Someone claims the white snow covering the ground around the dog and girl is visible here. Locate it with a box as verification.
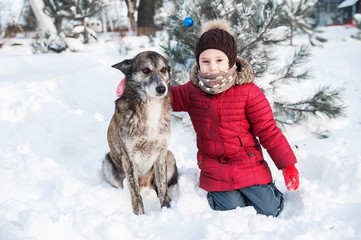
[0,27,361,240]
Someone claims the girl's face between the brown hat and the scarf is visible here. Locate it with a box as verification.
[199,49,229,74]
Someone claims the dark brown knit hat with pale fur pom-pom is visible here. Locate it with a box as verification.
[194,19,237,67]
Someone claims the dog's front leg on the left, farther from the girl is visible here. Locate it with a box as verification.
[123,157,144,215]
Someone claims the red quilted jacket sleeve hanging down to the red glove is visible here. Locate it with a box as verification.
[246,83,297,169]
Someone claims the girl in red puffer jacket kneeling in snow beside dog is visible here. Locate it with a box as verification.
[171,20,299,216]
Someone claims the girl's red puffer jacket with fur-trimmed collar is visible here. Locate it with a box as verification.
[171,58,297,191]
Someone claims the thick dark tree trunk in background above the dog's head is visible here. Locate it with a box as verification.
[137,0,156,37]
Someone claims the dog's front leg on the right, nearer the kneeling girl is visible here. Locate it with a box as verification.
[154,151,171,208]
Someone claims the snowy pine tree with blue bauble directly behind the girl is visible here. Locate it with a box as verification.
[163,0,344,135]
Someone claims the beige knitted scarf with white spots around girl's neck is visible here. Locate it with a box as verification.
[198,65,237,94]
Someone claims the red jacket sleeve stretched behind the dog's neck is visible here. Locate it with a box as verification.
[170,82,192,112]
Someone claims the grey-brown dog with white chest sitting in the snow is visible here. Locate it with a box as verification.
[102,51,178,215]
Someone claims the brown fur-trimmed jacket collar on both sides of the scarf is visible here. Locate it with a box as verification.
[189,57,254,87]
